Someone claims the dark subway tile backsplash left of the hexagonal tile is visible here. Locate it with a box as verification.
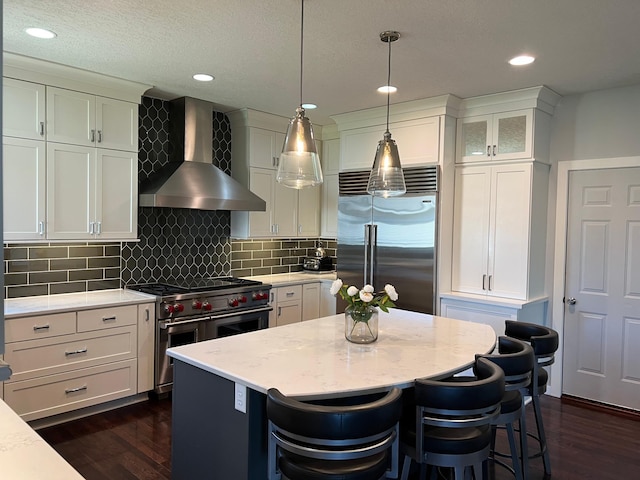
[4,243,121,298]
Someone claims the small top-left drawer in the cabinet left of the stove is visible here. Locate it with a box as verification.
[4,312,76,343]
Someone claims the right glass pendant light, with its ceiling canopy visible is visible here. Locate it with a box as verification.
[367,31,407,197]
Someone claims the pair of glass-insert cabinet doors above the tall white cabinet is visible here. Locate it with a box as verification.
[458,110,533,163]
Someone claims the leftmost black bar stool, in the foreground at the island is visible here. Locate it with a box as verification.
[267,388,402,480]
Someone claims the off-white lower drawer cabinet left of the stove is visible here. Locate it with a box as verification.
[4,304,155,421]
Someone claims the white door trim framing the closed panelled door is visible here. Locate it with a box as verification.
[547,157,640,397]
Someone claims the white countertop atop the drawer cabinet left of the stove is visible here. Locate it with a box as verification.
[4,288,156,318]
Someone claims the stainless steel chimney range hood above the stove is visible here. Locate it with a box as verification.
[139,97,267,212]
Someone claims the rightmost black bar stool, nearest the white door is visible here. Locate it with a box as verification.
[505,320,559,475]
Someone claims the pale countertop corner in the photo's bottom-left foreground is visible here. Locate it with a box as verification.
[0,400,84,480]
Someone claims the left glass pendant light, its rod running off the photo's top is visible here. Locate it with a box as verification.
[276,0,322,189]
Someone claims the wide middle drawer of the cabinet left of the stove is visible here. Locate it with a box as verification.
[5,325,137,382]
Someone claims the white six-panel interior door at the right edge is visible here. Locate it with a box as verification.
[563,168,640,409]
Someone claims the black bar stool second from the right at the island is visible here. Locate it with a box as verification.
[477,337,535,480]
